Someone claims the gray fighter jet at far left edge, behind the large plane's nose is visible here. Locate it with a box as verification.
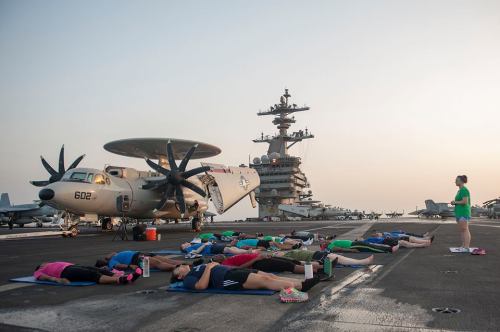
[0,193,57,229]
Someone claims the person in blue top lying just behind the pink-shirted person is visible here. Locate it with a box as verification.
[95,250,183,271]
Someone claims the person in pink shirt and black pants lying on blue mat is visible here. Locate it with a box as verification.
[33,262,142,285]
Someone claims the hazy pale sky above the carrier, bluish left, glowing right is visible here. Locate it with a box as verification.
[0,0,500,220]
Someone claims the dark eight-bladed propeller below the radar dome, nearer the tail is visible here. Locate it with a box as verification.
[142,141,210,215]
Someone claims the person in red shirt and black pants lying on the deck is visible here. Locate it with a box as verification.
[212,253,318,274]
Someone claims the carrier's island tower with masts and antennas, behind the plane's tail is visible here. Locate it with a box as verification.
[250,89,314,219]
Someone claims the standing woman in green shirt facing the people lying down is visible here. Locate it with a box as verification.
[451,175,471,252]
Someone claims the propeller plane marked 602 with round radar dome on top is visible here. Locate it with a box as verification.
[31,138,260,236]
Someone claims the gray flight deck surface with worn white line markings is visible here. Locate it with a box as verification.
[0,219,500,332]
